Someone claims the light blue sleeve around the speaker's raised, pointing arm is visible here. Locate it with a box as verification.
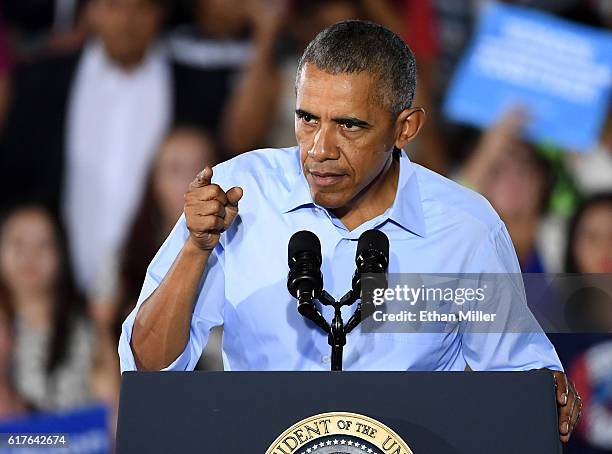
[119,214,225,372]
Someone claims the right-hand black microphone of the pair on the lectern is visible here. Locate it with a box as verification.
[347,229,389,332]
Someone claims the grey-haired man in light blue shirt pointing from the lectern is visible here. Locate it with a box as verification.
[119,21,580,439]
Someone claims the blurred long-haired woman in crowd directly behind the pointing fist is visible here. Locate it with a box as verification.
[91,127,218,394]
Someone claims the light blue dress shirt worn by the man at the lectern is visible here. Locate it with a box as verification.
[119,147,562,371]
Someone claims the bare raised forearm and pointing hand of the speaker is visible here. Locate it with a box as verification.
[131,167,242,370]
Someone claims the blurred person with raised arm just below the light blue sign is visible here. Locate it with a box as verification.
[458,110,552,273]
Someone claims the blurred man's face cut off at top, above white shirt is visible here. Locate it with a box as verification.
[91,0,163,67]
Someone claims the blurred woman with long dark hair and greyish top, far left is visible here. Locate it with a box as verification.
[0,205,93,410]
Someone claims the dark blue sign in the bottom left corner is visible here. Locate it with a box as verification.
[0,405,111,454]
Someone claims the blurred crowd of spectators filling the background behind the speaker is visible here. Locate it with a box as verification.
[0,0,612,452]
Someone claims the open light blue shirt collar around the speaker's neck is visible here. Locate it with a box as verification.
[281,150,426,237]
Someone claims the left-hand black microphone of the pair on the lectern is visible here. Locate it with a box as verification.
[287,230,323,304]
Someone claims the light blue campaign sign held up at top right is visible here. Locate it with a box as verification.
[444,3,612,151]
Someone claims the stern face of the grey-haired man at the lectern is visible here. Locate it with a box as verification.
[295,64,395,209]
